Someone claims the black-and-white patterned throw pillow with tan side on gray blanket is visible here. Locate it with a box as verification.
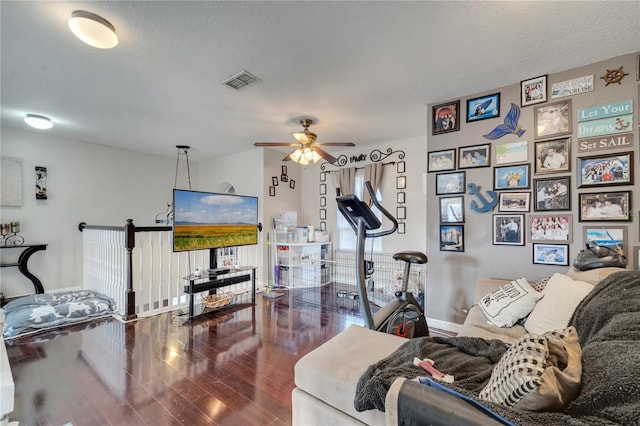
[478,327,582,411]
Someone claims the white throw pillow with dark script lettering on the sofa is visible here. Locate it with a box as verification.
[478,278,542,327]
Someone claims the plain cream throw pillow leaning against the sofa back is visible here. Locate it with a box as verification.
[524,273,593,334]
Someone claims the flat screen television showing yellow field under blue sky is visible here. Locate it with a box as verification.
[173,189,258,252]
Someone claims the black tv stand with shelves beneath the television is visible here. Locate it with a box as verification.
[184,266,257,320]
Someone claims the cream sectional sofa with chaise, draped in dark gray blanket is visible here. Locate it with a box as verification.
[292,267,640,425]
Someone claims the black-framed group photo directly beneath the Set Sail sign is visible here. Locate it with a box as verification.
[577,152,633,188]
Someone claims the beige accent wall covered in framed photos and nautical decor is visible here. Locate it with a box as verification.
[426,53,640,282]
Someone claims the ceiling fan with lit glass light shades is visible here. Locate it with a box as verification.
[253,118,356,166]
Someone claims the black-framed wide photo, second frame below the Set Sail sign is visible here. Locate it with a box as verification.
[578,191,631,222]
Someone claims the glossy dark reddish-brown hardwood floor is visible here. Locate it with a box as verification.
[7,286,448,426]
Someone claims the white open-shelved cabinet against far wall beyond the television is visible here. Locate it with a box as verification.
[276,242,331,288]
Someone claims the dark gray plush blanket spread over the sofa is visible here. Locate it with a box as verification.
[354,271,640,425]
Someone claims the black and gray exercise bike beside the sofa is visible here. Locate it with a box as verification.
[336,182,429,338]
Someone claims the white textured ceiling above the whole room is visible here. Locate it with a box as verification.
[0,1,640,159]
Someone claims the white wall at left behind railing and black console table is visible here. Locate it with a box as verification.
[0,128,190,297]
